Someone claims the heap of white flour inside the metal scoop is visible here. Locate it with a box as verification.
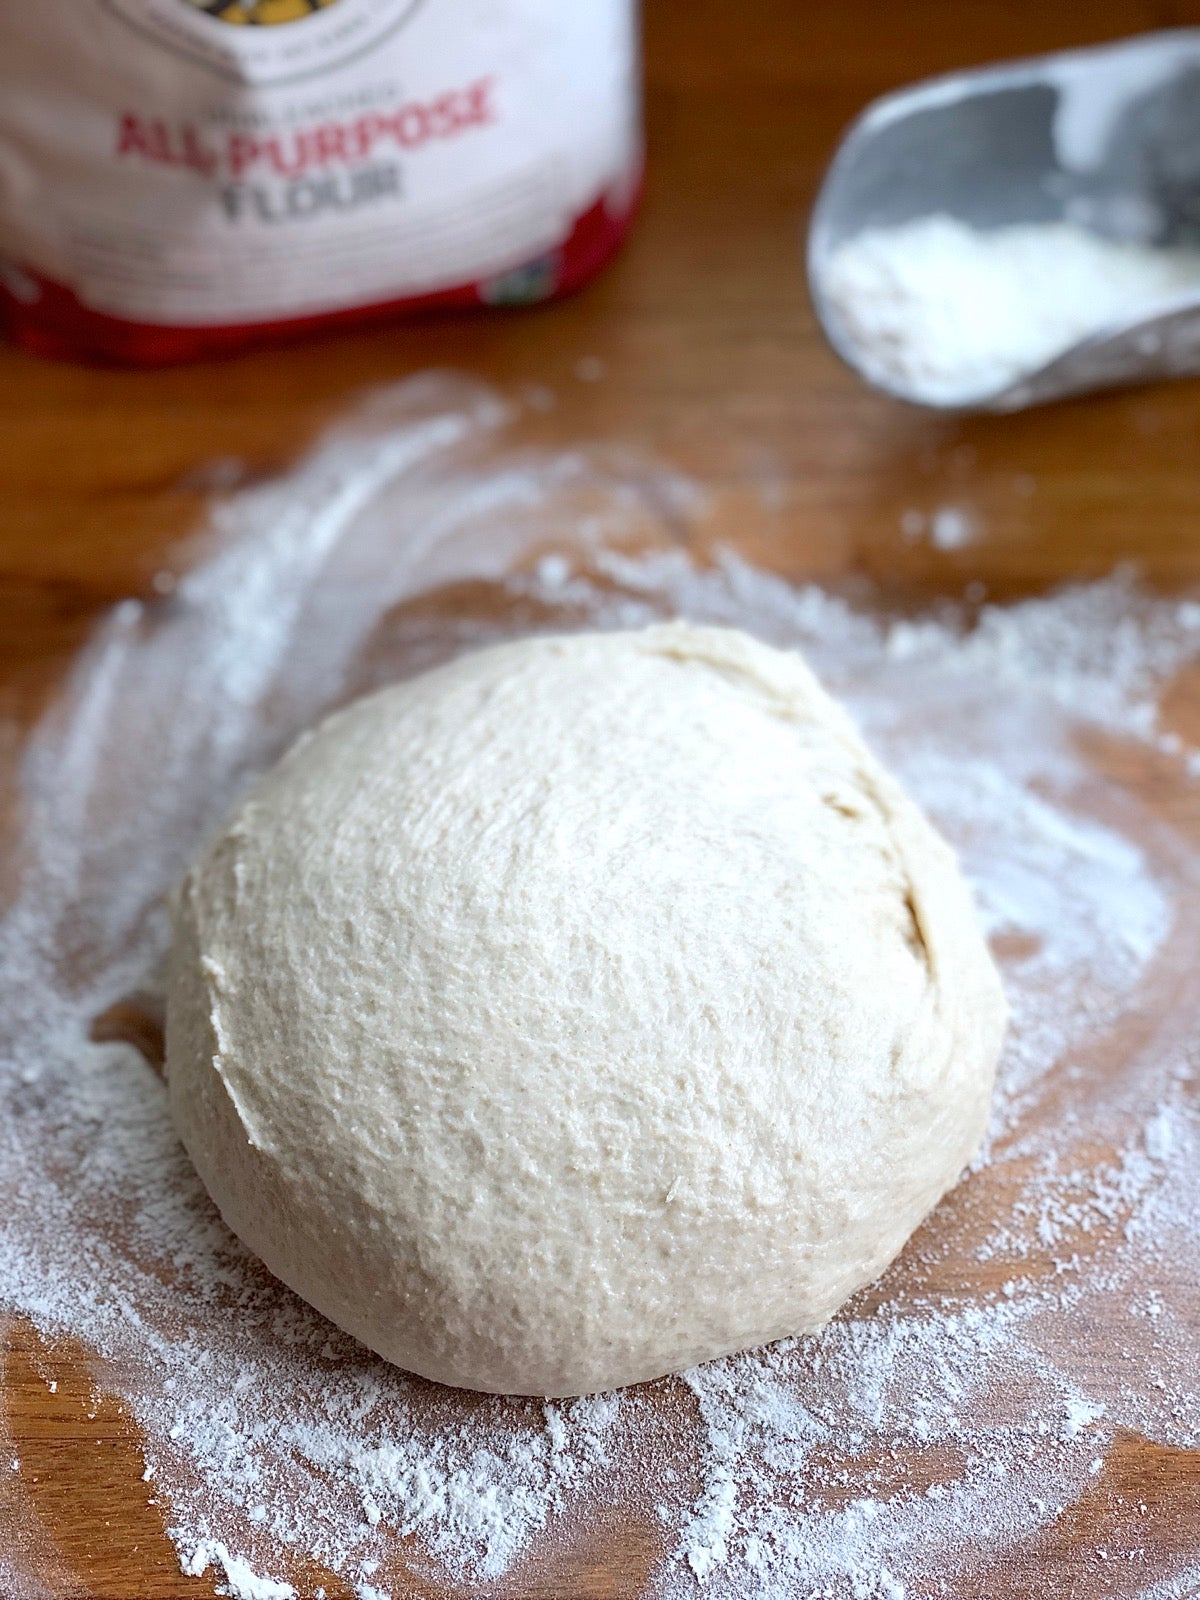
[821,214,1200,405]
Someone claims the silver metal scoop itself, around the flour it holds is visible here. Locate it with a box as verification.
[808,29,1200,411]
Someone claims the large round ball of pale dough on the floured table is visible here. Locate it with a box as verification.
[166,624,1005,1395]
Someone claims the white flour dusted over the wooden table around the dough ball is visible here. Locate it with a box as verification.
[0,379,1200,1600]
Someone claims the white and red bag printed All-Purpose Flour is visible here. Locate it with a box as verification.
[0,0,642,363]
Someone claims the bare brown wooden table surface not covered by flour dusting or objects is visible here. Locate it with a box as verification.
[0,0,1200,1600]
